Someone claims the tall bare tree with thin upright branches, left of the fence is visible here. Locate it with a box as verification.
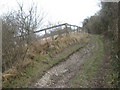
[16,3,43,62]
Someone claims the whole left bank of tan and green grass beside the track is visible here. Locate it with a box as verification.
[3,34,89,87]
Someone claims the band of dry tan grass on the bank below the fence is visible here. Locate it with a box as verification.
[2,33,88,84]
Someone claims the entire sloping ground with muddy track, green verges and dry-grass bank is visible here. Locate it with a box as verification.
[3,34,113,88]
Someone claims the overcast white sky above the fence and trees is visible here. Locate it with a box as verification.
[0,0,100,26]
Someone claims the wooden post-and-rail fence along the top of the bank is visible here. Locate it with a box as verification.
[17,23,84,40]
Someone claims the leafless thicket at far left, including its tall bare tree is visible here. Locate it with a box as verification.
[2,3,43,71]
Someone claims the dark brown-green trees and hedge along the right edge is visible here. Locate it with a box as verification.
[83,2,120,87]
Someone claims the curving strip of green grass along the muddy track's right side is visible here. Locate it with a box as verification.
[71,36,104,88]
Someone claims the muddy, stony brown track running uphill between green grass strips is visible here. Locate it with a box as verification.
[34,38,98,88]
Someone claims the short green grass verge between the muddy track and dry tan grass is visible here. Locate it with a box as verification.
[3,36,87,88]
